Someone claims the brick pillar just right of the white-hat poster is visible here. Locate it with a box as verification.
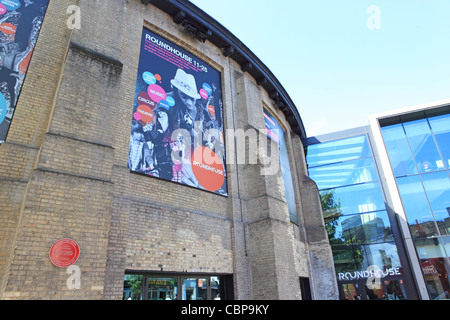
[235,71,300,299]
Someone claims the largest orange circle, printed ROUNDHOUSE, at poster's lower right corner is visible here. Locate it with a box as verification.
[191,147,225,192]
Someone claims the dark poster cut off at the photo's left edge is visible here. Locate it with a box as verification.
[0,0,49,144]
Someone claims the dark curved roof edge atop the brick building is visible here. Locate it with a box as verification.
[141,0,307,139]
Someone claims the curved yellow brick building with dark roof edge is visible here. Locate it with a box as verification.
[0,0,337,300]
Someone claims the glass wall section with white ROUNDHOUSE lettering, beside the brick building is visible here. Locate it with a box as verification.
[307,135,406,299]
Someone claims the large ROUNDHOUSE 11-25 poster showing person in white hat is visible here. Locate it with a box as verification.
[128,29,227,195]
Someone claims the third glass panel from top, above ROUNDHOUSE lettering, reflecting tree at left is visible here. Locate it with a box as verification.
[320,182,386,218]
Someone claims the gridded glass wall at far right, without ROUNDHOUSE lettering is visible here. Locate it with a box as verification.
[381,110,450,299]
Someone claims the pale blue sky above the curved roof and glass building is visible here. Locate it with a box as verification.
[187,0,450,136]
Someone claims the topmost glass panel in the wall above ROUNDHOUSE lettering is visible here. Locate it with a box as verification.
[306,135,371,167]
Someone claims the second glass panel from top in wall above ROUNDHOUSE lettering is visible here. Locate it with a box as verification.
[309,158,378,189]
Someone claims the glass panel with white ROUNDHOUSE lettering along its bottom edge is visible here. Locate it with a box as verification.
[332,242,401,274]
